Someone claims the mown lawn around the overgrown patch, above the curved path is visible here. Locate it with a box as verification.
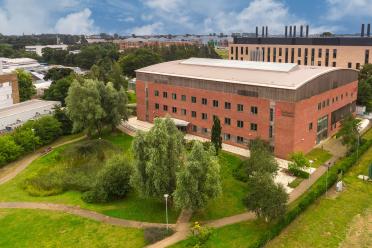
[0,133,179,223]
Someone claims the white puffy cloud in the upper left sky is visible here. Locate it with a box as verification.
[54,9,97,34]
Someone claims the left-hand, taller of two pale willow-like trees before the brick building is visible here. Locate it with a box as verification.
[132,118,185,199]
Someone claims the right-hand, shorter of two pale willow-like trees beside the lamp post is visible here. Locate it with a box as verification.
[173,142,222,210]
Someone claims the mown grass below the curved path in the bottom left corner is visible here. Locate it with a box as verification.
[0,209,145,248]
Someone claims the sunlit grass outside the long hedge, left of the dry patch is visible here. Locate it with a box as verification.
[267,145,372,248]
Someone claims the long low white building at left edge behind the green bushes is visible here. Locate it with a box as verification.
[0,99,60,132]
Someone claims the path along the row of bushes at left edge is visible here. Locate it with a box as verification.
[0,136,86,185]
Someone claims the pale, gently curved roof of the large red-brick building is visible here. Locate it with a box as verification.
[136,58,342,90]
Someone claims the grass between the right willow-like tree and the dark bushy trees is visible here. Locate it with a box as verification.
[193,152,247,221]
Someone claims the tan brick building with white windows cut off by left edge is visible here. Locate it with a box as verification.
[0,73,19,109]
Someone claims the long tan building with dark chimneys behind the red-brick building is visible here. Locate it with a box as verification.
[229,24,372,70]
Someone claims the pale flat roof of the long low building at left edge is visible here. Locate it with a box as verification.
[0,99,60,119]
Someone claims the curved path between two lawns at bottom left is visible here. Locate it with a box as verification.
[0,202,174,228]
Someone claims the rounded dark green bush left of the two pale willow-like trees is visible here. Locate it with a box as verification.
[83,156,133,202]
